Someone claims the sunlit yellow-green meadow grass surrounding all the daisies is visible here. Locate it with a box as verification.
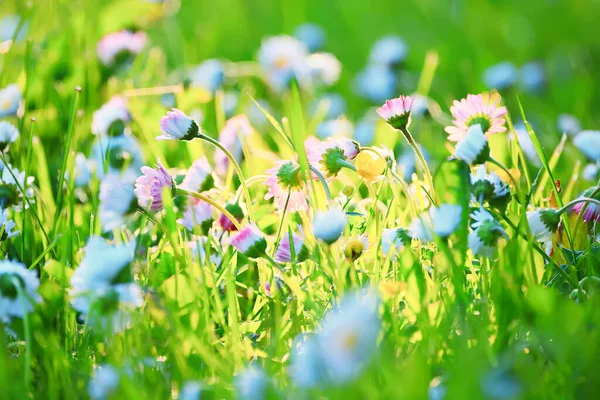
[0,0,600,399]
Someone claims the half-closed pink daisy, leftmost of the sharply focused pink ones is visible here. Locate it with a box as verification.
[134,161,173,211]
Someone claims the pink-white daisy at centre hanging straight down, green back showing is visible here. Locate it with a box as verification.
[265,161,308,213]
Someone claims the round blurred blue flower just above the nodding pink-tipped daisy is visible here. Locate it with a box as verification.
[354,65,398,103]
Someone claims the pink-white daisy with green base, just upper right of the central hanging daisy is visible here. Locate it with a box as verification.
[304,137,359,178]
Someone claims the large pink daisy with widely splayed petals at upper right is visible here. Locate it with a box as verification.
[445,93,508,142]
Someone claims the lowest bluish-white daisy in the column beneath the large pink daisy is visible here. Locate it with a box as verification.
[468,208,508,258]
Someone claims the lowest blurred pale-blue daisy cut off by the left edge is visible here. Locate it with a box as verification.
[0,260,42,324]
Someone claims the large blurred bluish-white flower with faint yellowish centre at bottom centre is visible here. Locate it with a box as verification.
[317,293,381,384]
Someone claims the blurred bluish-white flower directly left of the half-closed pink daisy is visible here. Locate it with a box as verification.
[98,173,136,232]
